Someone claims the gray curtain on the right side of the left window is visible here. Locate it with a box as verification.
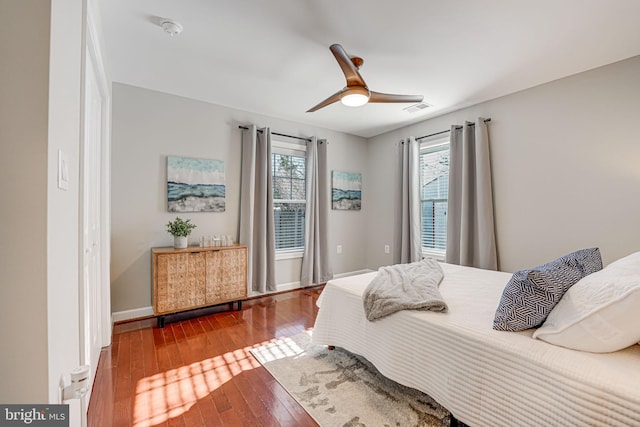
[300,137,333,286]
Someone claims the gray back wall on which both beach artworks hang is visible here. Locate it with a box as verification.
[111,84,370,312]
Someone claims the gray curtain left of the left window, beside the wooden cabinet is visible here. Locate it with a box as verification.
[240,125,276,292]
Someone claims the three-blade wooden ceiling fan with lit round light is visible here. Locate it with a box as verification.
[307,44,423,113]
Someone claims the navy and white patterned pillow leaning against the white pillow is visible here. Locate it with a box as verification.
[493,248,602,331]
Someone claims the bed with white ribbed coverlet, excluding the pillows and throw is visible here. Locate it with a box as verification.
[312,264,640,427]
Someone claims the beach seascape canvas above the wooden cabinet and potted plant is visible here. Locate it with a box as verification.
[167,156,226,212]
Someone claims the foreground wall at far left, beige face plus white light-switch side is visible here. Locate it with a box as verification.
[0,0,86,404]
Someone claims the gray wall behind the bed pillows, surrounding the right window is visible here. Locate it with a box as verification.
[366,57,640,271]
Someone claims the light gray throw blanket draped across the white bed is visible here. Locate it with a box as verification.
[363,258,447,320]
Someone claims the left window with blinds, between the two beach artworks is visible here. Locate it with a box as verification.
[271,141,307,252]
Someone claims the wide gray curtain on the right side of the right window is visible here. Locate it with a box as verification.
[445,117,498,270]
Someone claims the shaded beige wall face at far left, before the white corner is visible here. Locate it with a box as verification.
[0,1,51,403]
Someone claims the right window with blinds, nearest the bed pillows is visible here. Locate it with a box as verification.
[420,138,449,255]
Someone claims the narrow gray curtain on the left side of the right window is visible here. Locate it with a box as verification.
[393,137,422,264]
